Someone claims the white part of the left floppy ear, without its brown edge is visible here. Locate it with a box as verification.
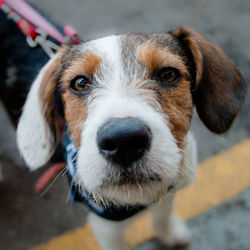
[17,58,55,170]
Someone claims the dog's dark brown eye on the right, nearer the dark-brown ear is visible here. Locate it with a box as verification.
[156,67,180,85]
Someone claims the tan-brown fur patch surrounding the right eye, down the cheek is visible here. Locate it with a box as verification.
[137,44,193,148]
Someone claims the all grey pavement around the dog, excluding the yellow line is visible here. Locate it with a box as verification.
[0,0,250,250]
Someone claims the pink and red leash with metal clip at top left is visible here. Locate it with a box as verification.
[0,0,81,58]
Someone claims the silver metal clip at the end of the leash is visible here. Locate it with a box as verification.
[26,28,59,58]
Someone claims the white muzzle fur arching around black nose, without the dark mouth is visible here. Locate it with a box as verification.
[78,96,181,202]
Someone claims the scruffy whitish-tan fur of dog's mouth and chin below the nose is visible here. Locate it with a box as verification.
[73,160,170,206]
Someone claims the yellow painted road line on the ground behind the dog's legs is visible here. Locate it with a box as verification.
[30,139,250,250]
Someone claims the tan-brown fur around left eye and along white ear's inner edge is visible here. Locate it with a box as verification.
[39,46,101,146]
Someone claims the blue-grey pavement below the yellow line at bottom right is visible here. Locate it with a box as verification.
[134,189,250,250]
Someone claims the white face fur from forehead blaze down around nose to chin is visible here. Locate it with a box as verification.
[74,36,195,204]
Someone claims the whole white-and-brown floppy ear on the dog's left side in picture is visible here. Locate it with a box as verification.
[17,49,63,170]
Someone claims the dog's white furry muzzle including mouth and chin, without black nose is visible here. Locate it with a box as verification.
[77,91,186,204]
